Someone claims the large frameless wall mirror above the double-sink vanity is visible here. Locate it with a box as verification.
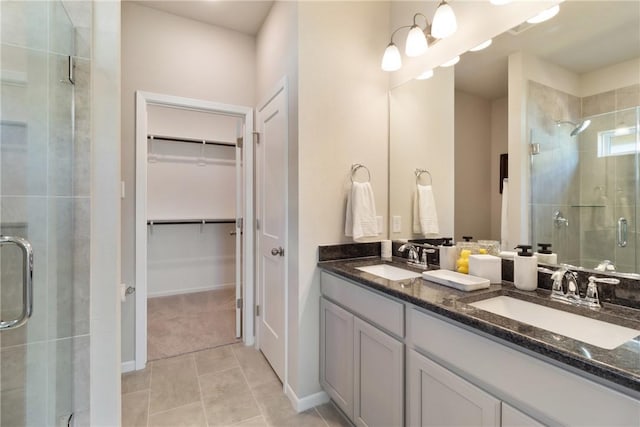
[389,1,640,273]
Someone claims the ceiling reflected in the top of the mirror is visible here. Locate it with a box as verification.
[455,1,640,99]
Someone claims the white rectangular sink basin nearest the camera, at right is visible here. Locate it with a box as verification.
[469,296,640,350]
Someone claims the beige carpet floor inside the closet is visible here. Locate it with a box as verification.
[147,288,238,360]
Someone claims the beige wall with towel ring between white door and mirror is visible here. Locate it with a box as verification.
[290,1,389,396]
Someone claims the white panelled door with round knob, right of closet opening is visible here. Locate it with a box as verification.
[256,85,288,382]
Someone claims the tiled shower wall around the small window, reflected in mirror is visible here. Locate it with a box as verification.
[578,84,640,272]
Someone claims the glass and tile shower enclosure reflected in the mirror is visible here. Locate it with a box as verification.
[527,82,640,273]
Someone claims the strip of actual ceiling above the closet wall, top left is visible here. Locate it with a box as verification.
[129,0,273,36]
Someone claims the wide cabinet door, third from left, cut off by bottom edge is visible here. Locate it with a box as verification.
[407,350,500,427]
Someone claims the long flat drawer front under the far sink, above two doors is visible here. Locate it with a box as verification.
[320,271,404,337]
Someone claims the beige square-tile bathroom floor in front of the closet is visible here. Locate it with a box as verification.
[122,343,350,427]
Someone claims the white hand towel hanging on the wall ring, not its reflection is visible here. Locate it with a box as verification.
[344,182,379,241]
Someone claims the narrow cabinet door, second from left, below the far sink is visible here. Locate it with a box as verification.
[353,317,404,427]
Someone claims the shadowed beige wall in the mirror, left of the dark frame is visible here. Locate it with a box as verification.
[454,90,492,241]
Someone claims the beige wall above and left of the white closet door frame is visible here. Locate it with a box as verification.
[121,2,256,362]
